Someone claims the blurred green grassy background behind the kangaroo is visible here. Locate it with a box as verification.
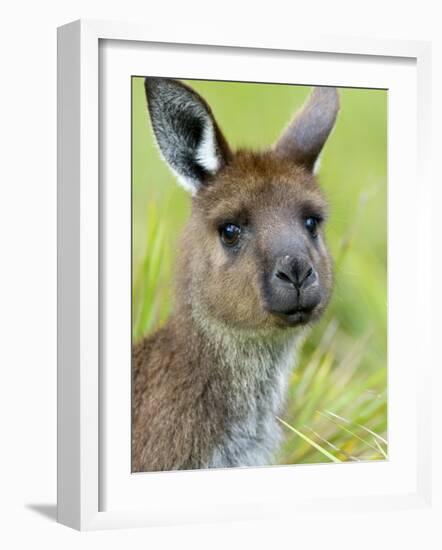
[132,77,387,464]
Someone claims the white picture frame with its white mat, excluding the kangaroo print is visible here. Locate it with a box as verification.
[58,21,432,530]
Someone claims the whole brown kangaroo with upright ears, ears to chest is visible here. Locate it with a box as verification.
[132,78,339,472]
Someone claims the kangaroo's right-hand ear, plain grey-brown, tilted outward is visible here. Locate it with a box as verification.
[274,88,339,171]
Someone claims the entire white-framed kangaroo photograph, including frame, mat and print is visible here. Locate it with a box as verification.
[58,21,432,530]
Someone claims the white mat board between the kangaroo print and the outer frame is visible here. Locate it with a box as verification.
[99,41,419,520]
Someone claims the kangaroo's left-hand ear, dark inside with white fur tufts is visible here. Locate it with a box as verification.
[145,77,231,195]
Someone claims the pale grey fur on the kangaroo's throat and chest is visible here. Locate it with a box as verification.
[193,308,296,468]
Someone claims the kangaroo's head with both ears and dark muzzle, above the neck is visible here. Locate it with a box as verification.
[145,78,339,330]
